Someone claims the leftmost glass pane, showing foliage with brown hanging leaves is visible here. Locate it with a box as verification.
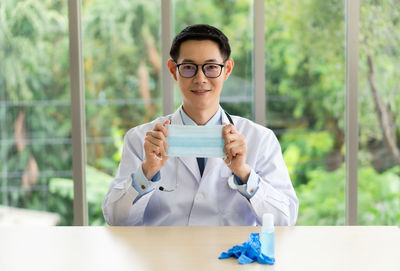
[0,0,73,225]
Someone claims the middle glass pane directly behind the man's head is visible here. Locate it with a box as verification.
[173,0,254,119]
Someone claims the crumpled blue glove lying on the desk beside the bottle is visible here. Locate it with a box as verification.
[218,233,275,265]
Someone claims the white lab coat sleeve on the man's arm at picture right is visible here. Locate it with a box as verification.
[250,131,299,226]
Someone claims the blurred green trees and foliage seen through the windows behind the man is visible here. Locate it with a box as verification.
[0,0,400,225]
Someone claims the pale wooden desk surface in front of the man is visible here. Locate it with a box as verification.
[0,226,400,271]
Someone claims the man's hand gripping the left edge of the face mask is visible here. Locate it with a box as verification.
[142,120,171,180]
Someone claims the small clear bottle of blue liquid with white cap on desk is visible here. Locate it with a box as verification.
[261,214,275,258]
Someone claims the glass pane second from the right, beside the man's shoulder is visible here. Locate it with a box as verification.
[265,0,345,225]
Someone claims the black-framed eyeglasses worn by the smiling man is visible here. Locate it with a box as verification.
[175,62,225,78]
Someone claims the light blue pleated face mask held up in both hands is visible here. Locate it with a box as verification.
[166,125,225,157]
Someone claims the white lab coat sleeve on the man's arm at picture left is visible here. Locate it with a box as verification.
[102,130,154,226]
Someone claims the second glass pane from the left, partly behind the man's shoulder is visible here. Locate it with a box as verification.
[82,0,164,225]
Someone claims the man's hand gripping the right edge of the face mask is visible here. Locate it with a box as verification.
[222,123,251,183]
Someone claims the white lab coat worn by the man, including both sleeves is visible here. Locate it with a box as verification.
[102,111,298,226]
